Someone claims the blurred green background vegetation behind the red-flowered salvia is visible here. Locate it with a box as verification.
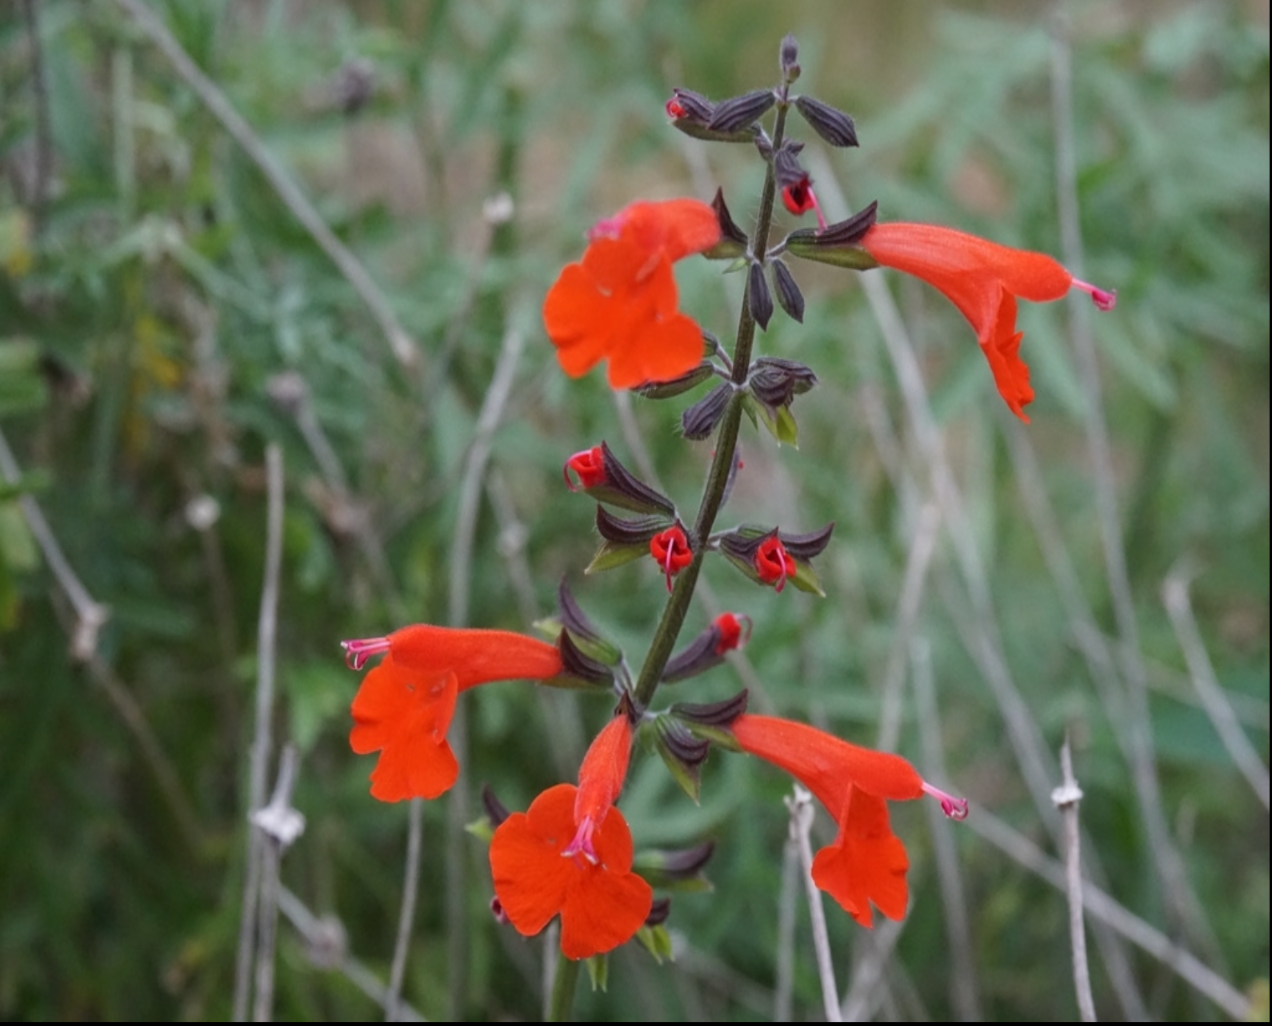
[0,0,1269,1021]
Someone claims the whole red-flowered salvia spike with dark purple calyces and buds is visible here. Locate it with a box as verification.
[343,37,1114,1017]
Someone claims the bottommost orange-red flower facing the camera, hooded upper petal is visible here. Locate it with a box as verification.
[490,712,654,959]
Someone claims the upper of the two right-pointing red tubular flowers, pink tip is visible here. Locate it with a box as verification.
[859,224,1117,423]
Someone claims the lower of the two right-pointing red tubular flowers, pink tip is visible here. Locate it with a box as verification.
[730,713,967,927]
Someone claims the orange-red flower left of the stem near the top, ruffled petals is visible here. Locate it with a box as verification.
[543,200,720,389]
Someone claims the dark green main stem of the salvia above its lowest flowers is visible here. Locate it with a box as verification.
[636,102,787,709]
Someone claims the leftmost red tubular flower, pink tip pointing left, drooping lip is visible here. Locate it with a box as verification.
[341,623,562,801]
